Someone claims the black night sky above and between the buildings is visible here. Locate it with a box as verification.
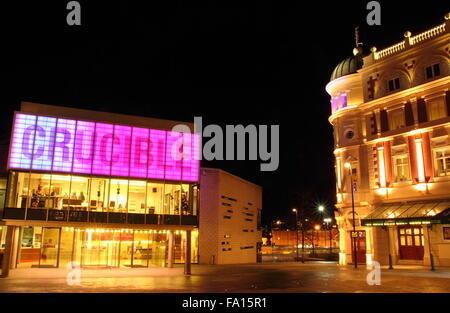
[0,0,450,223]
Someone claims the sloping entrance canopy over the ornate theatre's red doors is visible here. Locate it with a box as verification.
[361,199,450,226]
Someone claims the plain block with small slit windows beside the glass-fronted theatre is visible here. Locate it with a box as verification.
[199,168,262,264]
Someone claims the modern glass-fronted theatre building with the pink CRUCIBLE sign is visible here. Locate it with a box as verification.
[0,102,200,275]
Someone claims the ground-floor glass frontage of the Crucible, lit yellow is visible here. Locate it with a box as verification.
[18,226,198,268]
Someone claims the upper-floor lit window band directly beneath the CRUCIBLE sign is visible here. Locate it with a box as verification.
[6,171,198,224]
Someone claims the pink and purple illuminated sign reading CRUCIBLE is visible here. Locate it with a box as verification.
[8,113,200,182]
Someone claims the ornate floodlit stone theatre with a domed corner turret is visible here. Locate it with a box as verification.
[326,14,450,266]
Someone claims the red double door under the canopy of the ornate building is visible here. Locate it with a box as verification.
[398,226,424,260]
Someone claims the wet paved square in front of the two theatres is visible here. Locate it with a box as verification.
[0,262,450,293]
